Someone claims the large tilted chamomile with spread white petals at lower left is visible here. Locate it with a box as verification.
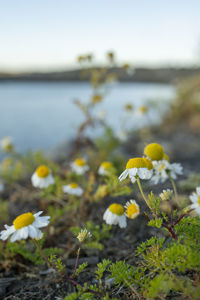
[0,211,50,242]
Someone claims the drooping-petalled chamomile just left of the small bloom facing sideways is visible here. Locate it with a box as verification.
[103,203,127,228]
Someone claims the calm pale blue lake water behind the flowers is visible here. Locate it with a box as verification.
[0,82,174,152]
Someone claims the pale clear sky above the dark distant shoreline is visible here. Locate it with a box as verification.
[0,0,200,71]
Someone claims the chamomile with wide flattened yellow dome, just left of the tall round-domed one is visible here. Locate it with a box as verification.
[119,157,153,183]
